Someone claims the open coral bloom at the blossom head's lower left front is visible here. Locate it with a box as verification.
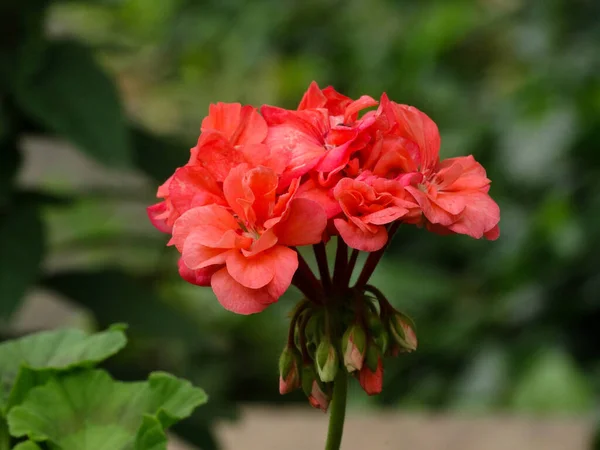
[172,164,327,314]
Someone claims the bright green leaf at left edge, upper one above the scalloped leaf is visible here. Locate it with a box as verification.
[0,326,127,412]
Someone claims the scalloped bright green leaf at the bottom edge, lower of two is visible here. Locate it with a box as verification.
[8,370,207,450]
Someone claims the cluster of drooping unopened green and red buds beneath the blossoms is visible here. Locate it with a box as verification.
[279,294,417,411]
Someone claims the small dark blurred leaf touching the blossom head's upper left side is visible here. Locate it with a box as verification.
[131,127,190,182]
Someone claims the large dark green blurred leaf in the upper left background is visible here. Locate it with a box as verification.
[14,41,132,167]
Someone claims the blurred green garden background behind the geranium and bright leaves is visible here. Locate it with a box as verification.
[0,0,600,450]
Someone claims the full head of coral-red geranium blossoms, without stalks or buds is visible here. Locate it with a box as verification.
[148,82,500,314]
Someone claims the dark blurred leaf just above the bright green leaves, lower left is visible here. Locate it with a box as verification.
[43,269,204,340]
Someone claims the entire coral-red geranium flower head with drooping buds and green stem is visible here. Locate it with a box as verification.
[148,82,500,449]
